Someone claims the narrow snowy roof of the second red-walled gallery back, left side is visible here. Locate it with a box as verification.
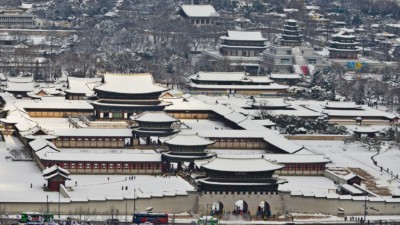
[53,128,132,137]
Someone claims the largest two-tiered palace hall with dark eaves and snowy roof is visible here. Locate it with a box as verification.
[92,73,170,120]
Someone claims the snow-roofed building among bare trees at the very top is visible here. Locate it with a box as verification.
[179,5,219,26]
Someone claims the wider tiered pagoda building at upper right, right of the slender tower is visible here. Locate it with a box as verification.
[328,31,361,59]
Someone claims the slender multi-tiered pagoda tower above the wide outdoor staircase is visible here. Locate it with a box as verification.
[281,19,303,46]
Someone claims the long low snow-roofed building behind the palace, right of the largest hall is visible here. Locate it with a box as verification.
[188,72,289,95]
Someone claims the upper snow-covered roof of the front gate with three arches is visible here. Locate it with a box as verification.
[195,156,284,172]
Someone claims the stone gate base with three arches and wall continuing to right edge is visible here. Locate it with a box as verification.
[198,192,400,216]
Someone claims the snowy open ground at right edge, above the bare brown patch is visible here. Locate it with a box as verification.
[293,140,400,194]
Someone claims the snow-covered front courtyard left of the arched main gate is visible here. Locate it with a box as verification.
[0,136,194,202]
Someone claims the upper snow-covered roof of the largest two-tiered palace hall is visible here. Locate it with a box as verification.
[94,73,167,94]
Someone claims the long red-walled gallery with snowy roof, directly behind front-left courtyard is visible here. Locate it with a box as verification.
[29,138,162,174]
